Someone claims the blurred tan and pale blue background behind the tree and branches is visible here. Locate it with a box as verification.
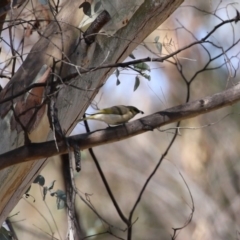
[1,0,240,240]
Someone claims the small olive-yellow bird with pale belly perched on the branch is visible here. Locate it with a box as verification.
[79,105,144,125]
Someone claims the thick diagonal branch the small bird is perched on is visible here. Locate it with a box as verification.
[0,84,240,169]
